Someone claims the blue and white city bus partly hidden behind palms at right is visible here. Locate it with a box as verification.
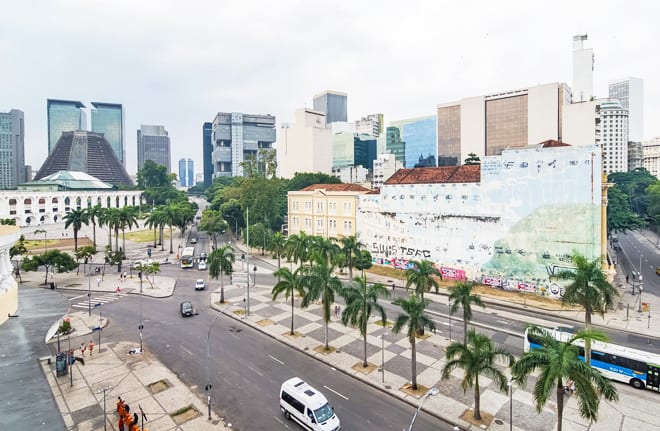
[523,328,660,392]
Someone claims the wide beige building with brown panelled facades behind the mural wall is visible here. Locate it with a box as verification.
[436,83,571,167]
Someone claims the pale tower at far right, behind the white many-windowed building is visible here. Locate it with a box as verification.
[609,77,644,142]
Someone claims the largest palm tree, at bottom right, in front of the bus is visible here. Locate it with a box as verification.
[511,326,619,431]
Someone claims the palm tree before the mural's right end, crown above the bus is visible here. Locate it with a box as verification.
[557,253,619,364]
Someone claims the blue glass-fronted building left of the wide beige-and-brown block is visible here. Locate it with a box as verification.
[390,116,438,168]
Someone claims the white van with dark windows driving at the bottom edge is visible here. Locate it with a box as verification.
[280,377,341,431]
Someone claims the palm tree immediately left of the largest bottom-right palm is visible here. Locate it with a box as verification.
[442,329,514,421]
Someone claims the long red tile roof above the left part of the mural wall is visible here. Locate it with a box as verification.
[385,165,481,184]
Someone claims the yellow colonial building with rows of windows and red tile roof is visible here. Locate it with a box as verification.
[287,184,371,238]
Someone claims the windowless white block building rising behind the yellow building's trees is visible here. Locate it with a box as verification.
[277,108,332,178]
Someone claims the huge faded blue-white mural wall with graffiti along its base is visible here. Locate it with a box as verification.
[358,146,601,296]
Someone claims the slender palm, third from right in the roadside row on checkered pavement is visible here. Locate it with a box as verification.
[392,293,435,391]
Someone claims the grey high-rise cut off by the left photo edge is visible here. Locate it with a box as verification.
[0,109,26,189]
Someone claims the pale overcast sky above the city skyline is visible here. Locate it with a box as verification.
[0,0,660,173]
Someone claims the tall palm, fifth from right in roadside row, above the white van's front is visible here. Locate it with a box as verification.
[301,254,342,350]
